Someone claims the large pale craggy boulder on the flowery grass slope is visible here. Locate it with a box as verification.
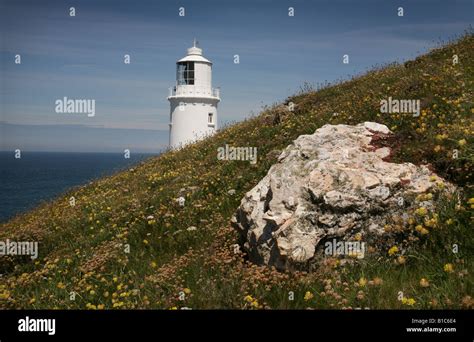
[232,122,452,270]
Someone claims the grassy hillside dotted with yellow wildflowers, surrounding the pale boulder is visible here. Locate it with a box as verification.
[0,33,474,309]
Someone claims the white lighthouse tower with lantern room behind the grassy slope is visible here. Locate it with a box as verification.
[168,40,220,149]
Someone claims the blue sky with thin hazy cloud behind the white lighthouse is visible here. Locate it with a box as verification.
[0,0,474,152]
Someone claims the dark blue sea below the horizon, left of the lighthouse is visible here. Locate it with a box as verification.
[0,151,153,222]
